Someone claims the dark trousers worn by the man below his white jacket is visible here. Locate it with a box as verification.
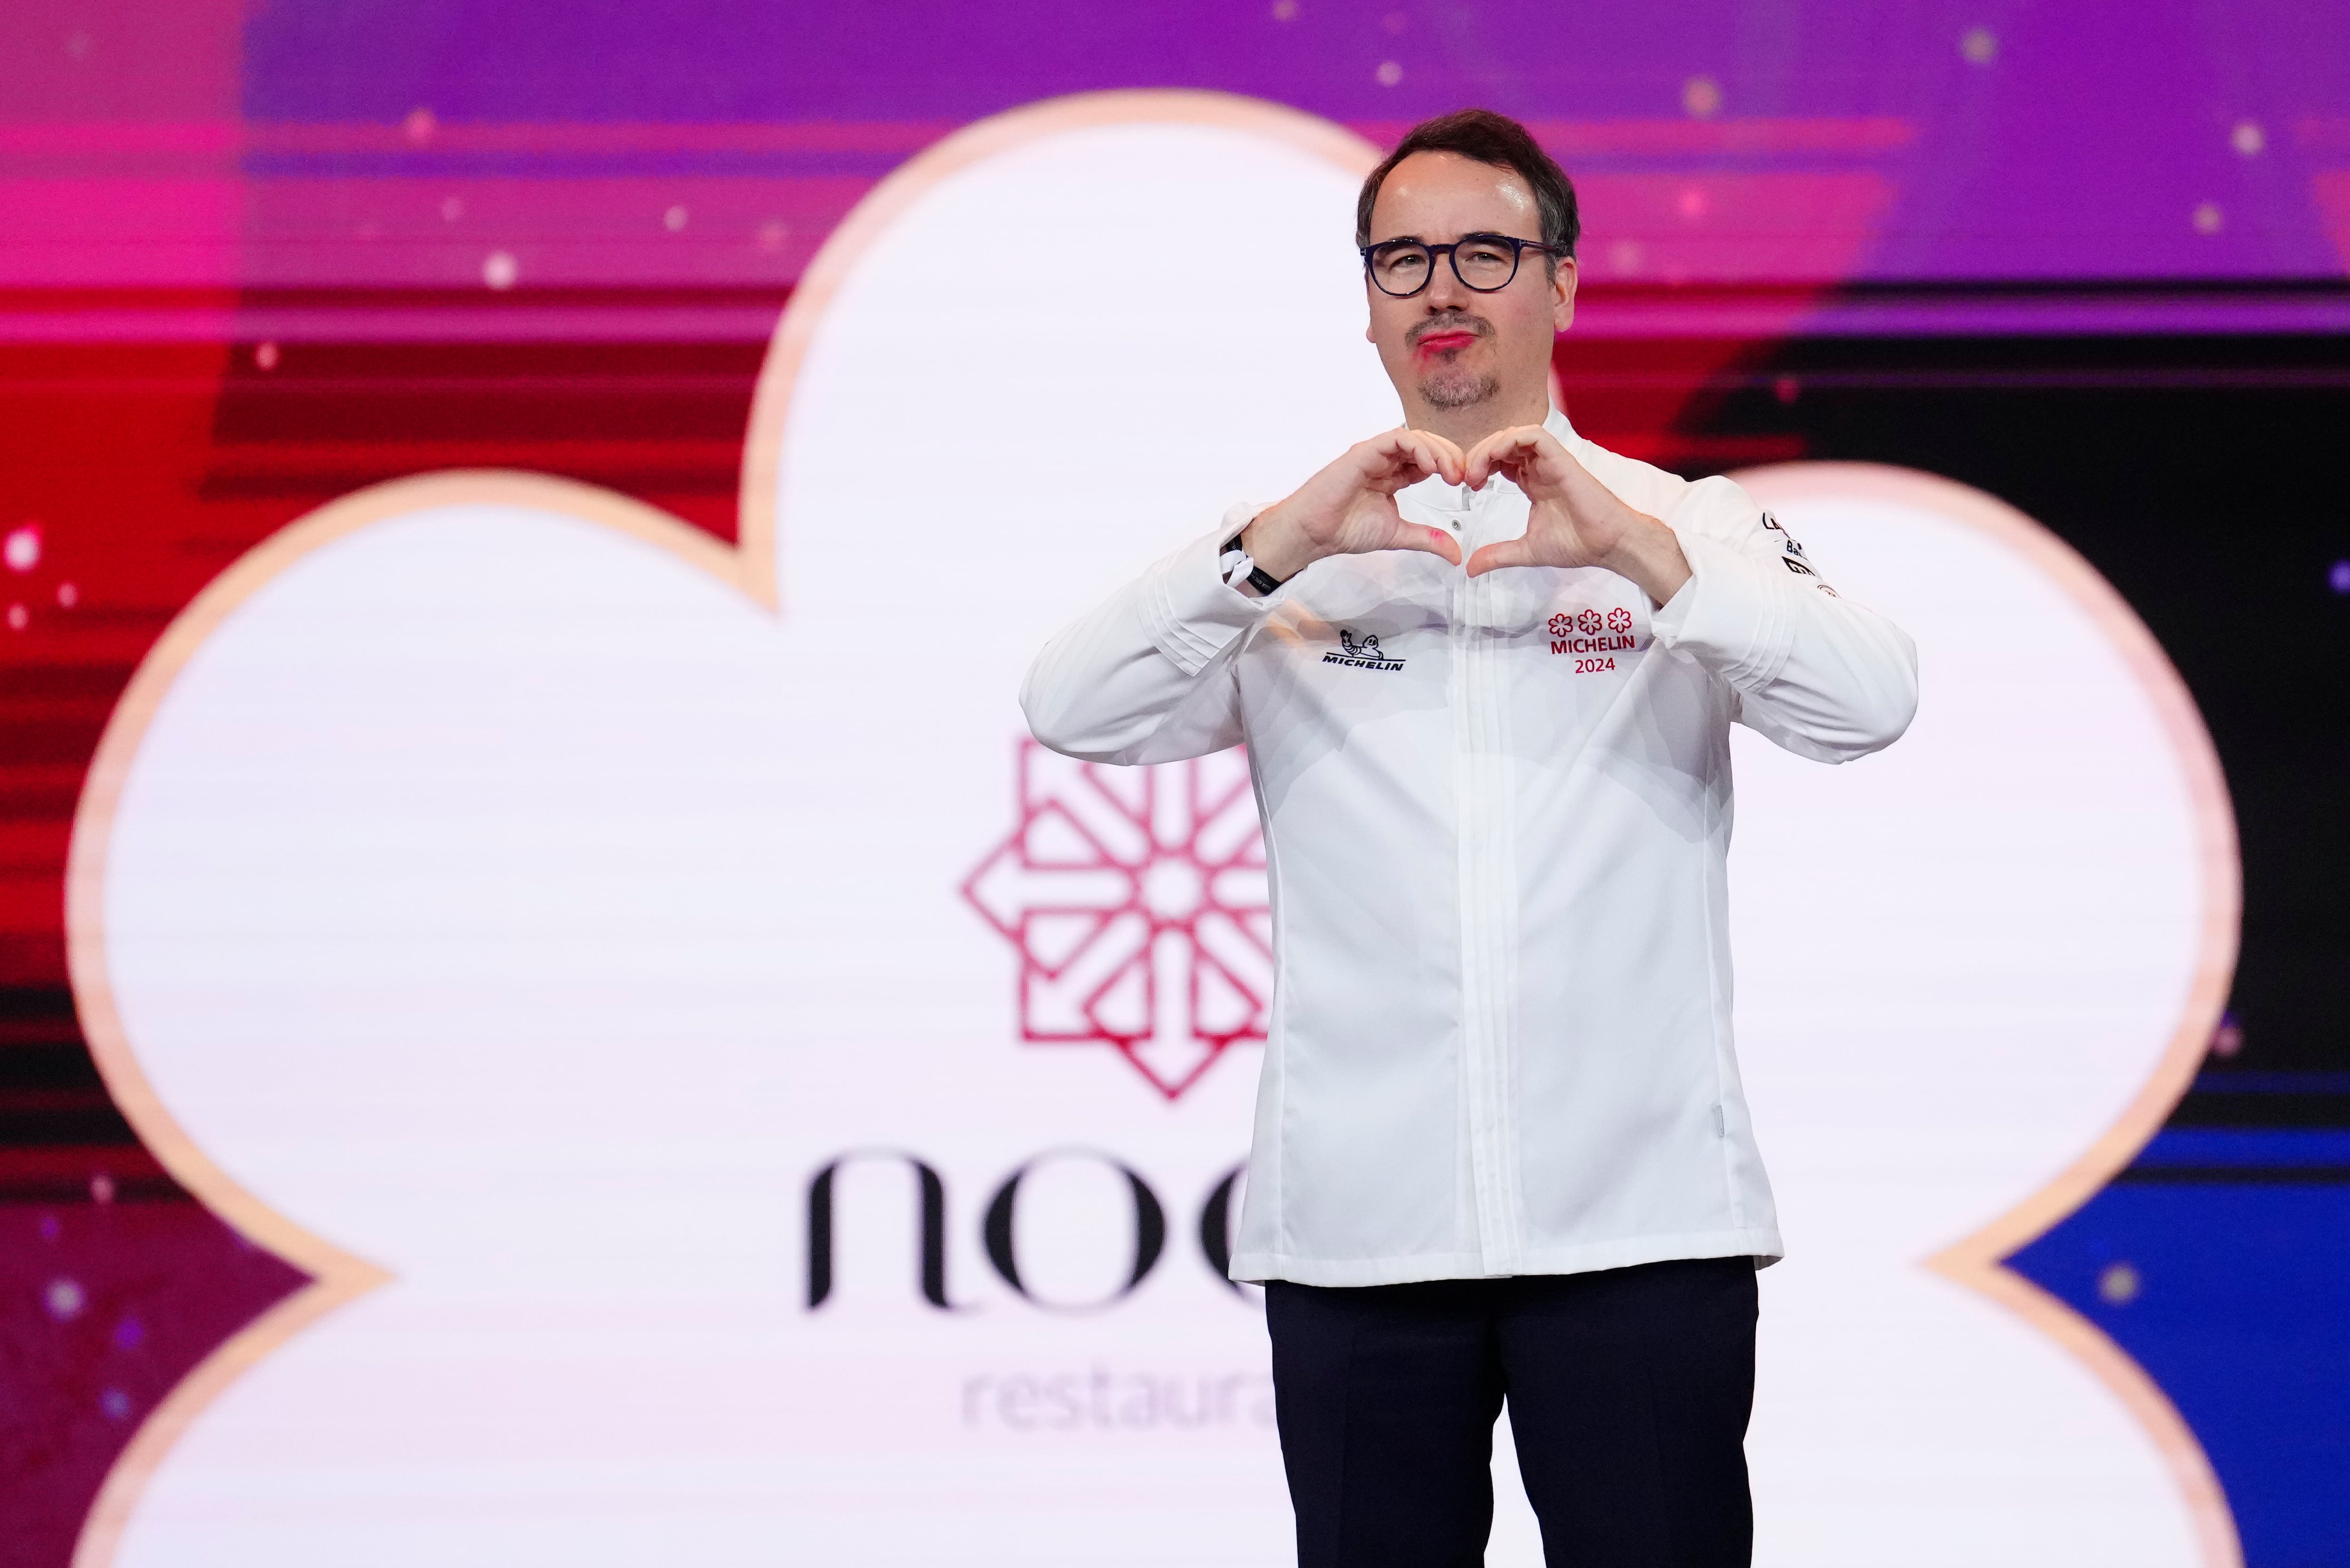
[1264,1258,1755,1568]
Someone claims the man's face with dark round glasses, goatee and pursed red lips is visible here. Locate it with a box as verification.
[1363,153,1574,423]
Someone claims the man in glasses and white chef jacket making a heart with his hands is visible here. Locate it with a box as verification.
[1022,110,1918,1568]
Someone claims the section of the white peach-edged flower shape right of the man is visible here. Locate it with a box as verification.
[1730,463,2237,1568]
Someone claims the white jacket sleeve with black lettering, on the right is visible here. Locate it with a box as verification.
[1652,479,1918,761]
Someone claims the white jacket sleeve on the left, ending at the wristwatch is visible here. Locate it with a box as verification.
[1020,505,1278,764]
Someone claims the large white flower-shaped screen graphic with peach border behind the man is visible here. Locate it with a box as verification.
[68,94,2235,1568]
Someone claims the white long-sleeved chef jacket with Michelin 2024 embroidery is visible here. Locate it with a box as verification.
[1020,414,1918,1286]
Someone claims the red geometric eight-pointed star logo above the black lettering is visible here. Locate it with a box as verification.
[964,740,1274,1100]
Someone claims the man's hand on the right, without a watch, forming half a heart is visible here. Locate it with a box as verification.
[1466,425,1690,604]
